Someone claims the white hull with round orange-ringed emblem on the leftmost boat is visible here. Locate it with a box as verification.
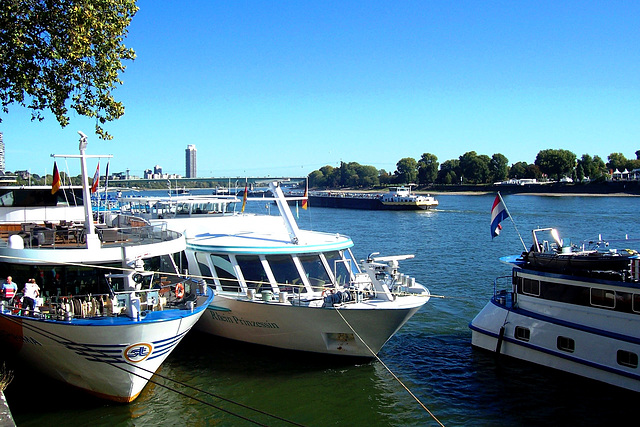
[0,307,204,402]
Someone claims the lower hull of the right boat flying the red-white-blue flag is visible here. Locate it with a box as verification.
[470,301,640,391]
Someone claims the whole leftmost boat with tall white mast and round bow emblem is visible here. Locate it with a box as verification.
[0,135,214,402]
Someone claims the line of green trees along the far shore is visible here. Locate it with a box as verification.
[309,149,640,188]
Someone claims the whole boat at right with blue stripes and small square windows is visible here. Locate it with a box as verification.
[470,228,640,392]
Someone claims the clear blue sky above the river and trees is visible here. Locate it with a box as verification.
[0,0,640,177]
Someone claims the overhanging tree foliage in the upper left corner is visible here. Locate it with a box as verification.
[0,0,138,139]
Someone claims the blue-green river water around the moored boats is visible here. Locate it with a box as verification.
[5,195,640,426]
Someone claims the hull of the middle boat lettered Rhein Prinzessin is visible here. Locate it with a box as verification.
[196,295,426,357]
